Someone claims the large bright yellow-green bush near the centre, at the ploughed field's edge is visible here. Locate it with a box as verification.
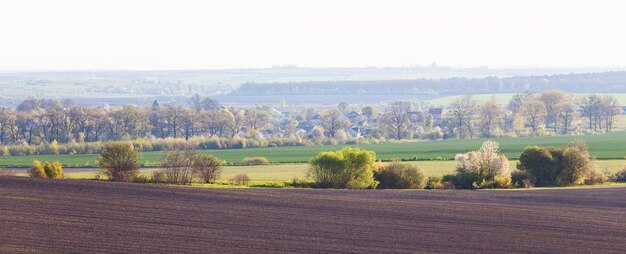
[309,147,378,189]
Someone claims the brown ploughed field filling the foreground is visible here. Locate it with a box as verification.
[0,177,626,253]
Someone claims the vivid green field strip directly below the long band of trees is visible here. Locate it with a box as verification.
[0,132,626,167]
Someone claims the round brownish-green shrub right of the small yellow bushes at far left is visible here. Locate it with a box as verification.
[96,142,140,182]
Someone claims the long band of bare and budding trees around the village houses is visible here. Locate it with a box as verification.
[0,90,622,150]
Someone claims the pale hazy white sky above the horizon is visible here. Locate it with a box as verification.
[0,0,626,70]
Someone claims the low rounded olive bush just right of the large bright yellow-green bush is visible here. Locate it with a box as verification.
[374,162,426,189]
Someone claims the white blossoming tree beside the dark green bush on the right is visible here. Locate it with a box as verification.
[454,140,511,181]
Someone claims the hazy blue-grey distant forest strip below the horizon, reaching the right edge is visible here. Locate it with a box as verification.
[230,72,626,95]
